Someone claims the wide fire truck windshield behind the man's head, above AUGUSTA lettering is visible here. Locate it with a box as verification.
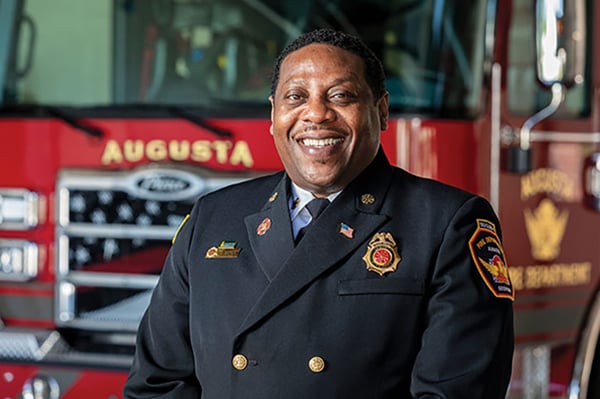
[0,0,494,117]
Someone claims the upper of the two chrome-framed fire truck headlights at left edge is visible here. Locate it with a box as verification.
[0,188,40,230]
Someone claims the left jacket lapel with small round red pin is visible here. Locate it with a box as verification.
[244,177,294,281]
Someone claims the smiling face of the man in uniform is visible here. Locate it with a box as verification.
[270,44,388,196]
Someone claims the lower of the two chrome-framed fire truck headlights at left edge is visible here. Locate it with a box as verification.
[0,240,38,281]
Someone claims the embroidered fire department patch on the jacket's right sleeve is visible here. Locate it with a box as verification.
[469,219,515,301]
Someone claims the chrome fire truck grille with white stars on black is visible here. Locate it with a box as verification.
[55,167,251,332]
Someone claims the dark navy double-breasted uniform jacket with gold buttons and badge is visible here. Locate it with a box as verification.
[124,151,514,399]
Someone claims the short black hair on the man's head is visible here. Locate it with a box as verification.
[271,29,385,100]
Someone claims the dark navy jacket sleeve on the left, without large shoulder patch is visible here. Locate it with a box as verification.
[123,203,201,399]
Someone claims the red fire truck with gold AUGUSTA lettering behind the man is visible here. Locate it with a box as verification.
[0,0,600,399]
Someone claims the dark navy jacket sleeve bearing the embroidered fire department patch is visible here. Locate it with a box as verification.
[411,197,514,399]
